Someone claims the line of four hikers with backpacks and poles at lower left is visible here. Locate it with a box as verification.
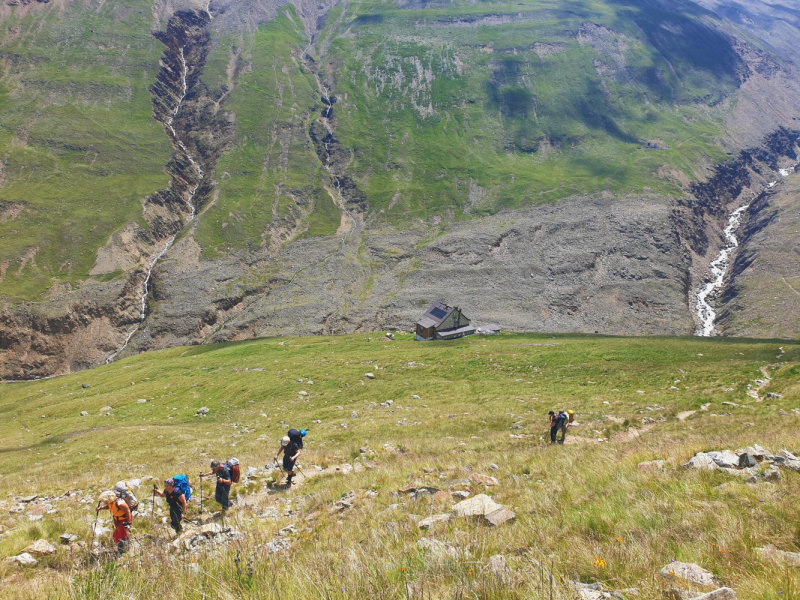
[90,429,307,556]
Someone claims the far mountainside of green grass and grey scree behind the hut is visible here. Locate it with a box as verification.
[0,0,800,379]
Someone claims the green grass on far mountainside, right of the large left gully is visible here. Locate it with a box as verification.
[194,0,735,253]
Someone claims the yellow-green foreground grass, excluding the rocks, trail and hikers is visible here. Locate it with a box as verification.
[0,335,800,600]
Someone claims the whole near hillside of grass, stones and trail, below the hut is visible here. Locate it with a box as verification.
[0,334,800,600]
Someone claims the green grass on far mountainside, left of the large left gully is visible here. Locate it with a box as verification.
[0,0,172,299]
